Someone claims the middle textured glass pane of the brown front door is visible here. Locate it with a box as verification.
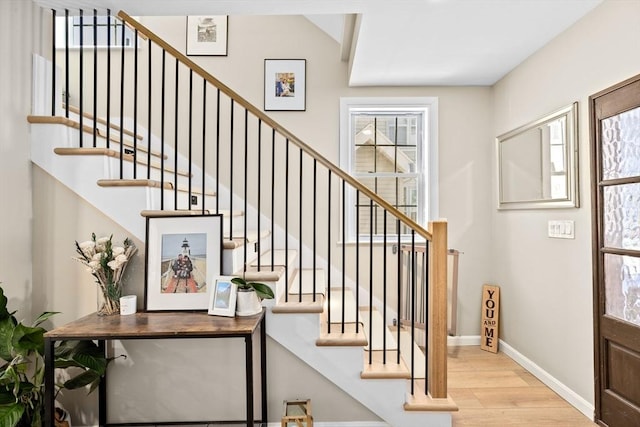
[604,184,640,250]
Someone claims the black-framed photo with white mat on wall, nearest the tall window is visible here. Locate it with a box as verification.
[264,59,307,111]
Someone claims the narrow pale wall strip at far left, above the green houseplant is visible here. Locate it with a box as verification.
[0,0,40,321]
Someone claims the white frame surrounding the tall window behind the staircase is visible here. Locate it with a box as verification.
[340,97,438,243]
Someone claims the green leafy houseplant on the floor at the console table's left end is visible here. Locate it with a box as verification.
[0,287,113,427]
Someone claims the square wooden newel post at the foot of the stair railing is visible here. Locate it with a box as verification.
[427,220,448,399]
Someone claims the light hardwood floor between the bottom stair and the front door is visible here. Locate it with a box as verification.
[448,346,597,427]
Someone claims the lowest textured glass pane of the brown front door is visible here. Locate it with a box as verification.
[604,254,640,325]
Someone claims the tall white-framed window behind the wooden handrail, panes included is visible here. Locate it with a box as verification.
[340,98,438,241]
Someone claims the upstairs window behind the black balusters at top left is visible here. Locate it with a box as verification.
[56,12,134,48]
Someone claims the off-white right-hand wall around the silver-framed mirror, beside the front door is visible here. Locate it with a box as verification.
[486,0,640,412]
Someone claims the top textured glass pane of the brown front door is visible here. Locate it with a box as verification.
[602,108,640,179]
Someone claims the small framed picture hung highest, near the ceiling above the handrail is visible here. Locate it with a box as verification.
[187,15,229,56]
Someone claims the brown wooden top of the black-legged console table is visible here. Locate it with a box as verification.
[45,309,264,340]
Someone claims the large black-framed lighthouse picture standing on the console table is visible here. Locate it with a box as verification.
[144,215,222,311]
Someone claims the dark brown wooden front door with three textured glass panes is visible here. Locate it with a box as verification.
[589,76,640,427]
